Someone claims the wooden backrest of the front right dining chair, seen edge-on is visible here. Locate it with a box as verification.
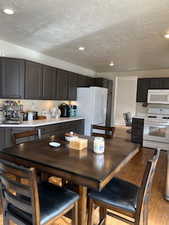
[136,149,160,225]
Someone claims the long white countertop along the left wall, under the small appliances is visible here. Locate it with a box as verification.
[0,117,84,128]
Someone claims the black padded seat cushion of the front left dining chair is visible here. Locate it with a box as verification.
[8,182,79,225]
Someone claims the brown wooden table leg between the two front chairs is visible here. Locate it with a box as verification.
[78,186,87,225]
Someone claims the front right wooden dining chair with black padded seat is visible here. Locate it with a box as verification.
[88,150,160,225]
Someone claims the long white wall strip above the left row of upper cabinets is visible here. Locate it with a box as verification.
[0,40,95,77]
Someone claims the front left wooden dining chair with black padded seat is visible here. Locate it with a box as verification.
[0,160,79,225]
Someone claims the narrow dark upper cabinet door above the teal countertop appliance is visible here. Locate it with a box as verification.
[68,72,77,100]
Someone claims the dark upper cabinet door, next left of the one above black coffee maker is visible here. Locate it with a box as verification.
[43,66,57,100]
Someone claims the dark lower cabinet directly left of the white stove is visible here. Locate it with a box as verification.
[131,118,144,145]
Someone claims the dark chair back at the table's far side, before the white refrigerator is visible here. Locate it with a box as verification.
[91,125,115,138]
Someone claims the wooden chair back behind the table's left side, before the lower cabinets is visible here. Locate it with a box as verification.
[13,130,40,144]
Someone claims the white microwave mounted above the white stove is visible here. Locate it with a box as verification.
[148,89,169,104]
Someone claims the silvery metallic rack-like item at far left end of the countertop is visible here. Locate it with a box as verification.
[3,101,23,124]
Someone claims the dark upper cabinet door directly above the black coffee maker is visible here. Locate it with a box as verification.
[57,69,69,100]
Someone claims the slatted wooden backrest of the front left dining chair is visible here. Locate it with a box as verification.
[0,160,40,225]
